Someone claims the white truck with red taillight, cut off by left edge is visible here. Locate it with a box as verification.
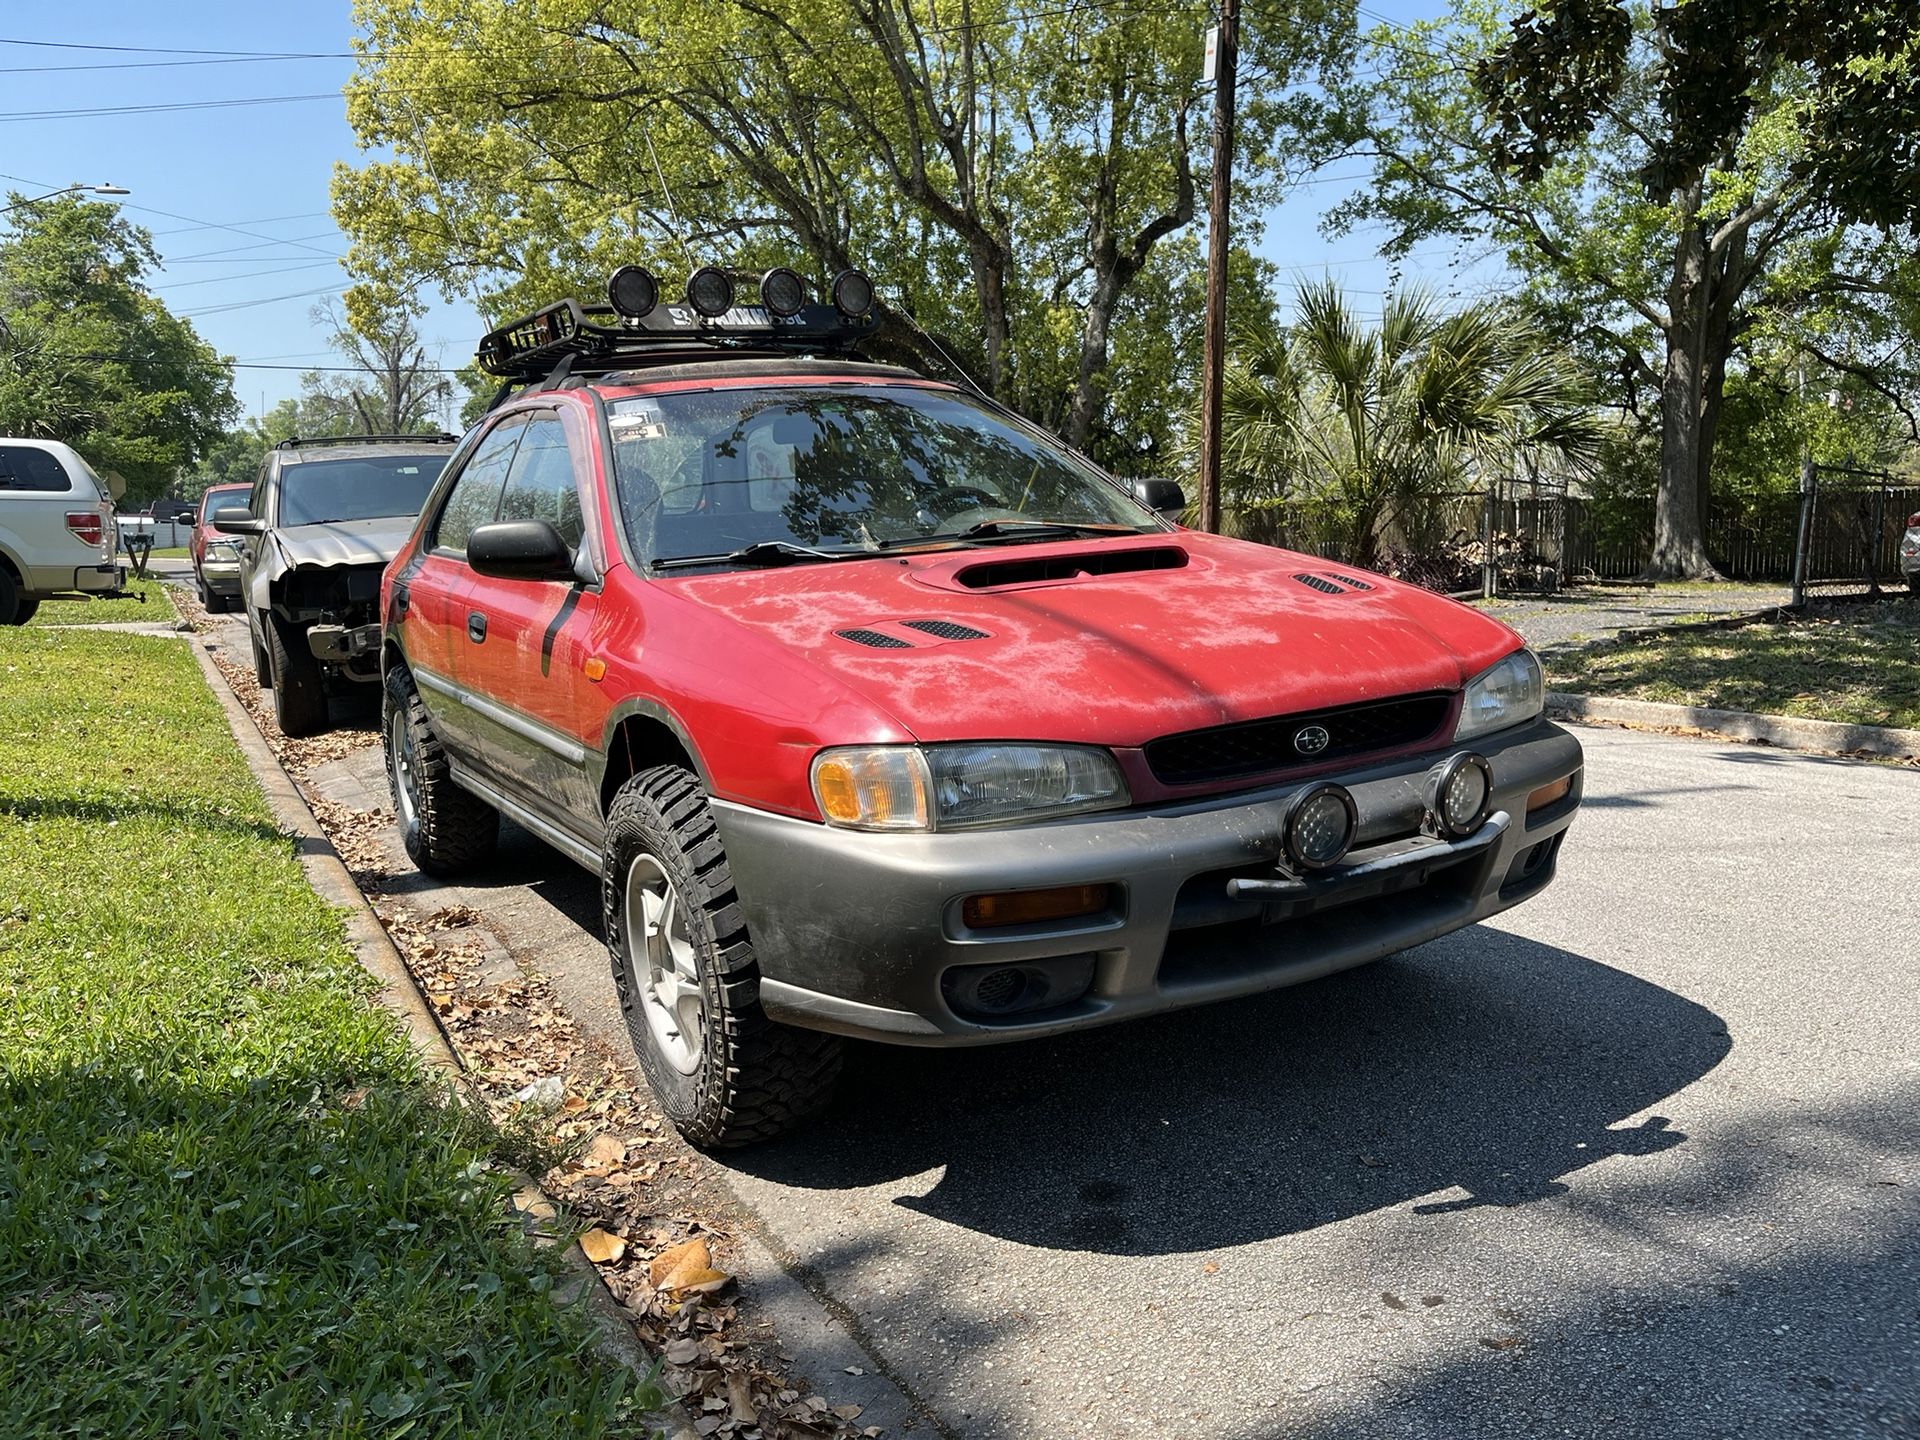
[0,436,127,626]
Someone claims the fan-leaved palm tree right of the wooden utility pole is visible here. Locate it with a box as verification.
[1221,280,1599,566]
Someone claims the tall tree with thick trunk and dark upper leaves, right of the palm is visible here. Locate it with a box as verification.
[1336,0,1912,578]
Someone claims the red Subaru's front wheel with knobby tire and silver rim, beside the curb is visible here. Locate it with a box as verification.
[601,766,841,1150]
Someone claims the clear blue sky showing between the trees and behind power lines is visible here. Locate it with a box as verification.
[0,0,1482,426]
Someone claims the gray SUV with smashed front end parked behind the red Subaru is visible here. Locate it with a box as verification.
[213,434,455,735]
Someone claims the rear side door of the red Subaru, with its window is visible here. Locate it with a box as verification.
[403,413,526,764]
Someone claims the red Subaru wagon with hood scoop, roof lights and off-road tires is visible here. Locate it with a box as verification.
[382,267,1580,1146]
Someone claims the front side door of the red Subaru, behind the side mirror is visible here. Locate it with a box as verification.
[451,411,599,839]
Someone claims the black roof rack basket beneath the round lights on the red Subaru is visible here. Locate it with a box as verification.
[478,300,877,389]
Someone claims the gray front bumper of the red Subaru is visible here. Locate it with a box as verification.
[714,720,1580,1044]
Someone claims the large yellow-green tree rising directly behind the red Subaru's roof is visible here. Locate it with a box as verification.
[334,0,1354,464]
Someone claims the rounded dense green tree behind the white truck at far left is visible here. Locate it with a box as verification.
[0,194,236,503]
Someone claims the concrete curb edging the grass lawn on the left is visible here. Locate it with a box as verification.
[188,636,693,1440]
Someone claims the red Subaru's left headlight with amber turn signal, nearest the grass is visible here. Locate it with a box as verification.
[812,745,1129,829]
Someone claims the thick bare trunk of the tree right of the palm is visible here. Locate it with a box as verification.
[1642,192,1720,580]
